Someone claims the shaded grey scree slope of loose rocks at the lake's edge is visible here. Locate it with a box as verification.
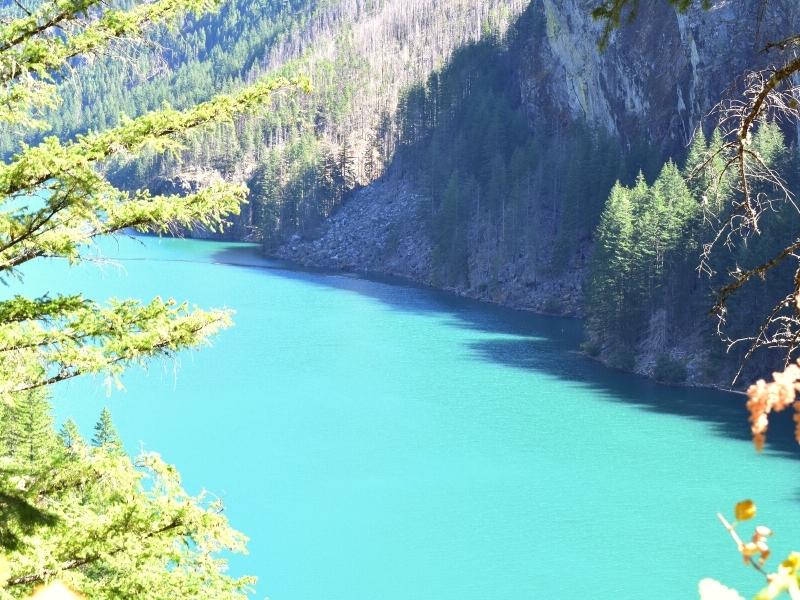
[272,180,582,316]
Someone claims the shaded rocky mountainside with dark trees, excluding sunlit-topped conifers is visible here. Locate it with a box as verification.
[276,0,800,384]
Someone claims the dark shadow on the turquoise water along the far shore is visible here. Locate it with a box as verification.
[205,247,799,458]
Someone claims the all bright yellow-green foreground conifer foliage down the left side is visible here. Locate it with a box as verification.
[0,0,309,599]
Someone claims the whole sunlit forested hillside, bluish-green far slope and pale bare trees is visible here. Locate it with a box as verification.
[0,0,525,239]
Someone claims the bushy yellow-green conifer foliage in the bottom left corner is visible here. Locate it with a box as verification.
[0,391,253,599]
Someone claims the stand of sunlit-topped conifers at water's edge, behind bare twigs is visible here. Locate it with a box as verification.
[585,122,800,381]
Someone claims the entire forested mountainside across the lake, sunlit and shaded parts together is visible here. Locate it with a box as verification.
[23,0,800,382]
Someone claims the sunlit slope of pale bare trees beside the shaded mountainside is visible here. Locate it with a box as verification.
[106,0,525,241]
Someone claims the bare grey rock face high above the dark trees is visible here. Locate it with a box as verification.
[519,0,800,152]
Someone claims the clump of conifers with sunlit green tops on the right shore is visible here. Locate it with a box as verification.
[586,122,798,381]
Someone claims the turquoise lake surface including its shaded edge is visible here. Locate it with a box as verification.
[11,238,800,600]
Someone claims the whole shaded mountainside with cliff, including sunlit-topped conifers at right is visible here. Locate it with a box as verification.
[280,2,800,384]
